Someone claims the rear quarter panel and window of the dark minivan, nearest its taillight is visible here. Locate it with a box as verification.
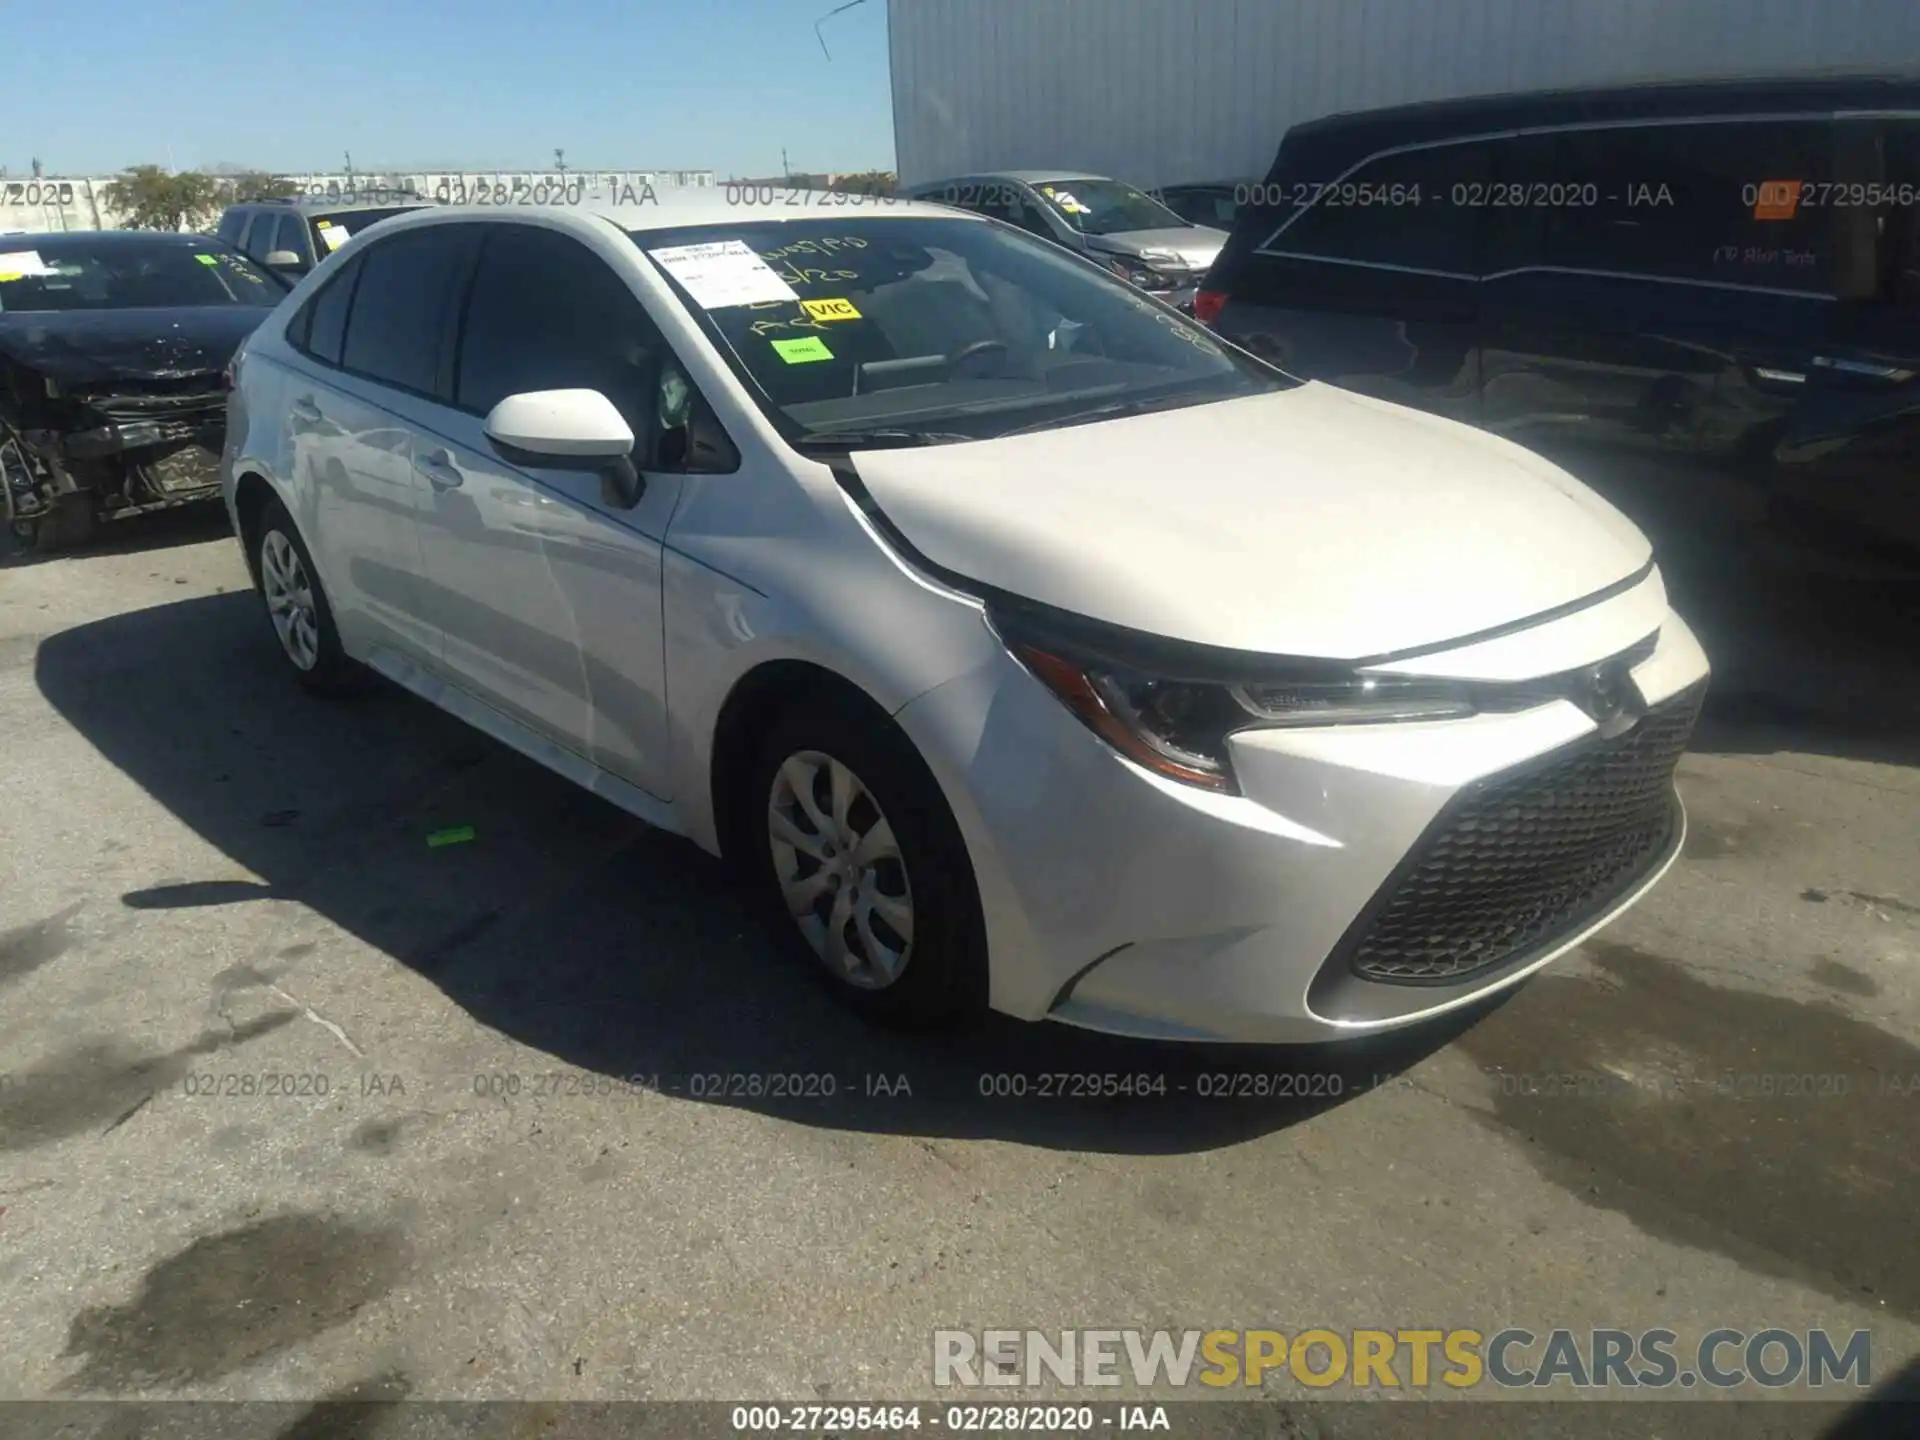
[1219,140,1490,420]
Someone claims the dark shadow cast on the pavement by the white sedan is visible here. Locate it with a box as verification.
[36,593,1486,1154]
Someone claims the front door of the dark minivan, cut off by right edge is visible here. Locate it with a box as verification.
[1772,115,1920,557]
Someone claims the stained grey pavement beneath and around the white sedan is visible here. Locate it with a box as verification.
[0,487,1920,1436]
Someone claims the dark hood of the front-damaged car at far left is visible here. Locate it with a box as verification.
[0,305,273,386]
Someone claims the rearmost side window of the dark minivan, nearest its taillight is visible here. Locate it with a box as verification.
[1274,142,1488,275]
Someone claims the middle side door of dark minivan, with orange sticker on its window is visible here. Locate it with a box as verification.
[1480,115,1837,532]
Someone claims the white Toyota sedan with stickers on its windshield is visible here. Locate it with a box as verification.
[223,196,1707,1041]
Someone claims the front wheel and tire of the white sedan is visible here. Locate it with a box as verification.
[735,693,987,1029]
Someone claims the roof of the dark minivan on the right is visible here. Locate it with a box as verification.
[1283,71,1920,169]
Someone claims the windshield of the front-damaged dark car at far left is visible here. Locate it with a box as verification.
[0,236,286,311]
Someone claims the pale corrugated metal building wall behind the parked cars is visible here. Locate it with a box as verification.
[887,0,1920,186]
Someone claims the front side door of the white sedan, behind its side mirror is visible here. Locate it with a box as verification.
[415,223,682,799]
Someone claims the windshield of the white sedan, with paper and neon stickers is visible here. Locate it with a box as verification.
[634,215,1292,444]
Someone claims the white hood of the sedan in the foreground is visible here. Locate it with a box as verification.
[852,382,1651,659]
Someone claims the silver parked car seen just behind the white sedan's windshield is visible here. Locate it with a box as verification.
[908,171,1227,313]
